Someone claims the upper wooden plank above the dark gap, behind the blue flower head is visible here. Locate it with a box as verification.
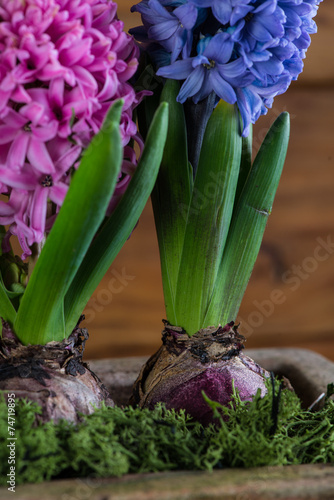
[118,0,334,85]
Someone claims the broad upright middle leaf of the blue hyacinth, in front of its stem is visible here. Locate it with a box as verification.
[172,101,242,335]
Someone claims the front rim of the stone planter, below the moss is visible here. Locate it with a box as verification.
[0,465,334,500]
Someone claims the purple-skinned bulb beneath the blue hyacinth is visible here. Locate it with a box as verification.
[131,322,269,425]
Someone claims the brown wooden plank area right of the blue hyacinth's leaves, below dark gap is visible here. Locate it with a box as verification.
[240,88,334,359]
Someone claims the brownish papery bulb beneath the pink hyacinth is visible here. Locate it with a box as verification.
[0,323,114,422]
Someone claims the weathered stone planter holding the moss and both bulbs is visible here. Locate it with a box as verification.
[0,348,334,500]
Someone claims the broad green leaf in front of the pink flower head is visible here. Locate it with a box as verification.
[14,101,123,344]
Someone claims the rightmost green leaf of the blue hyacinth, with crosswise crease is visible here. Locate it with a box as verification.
[205,113,290,325]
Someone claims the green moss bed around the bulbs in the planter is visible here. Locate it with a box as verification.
[0,378,334,485]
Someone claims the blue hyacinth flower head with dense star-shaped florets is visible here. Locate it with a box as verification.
[130,0,322,136]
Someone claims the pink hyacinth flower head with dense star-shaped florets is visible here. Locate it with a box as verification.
[0,0,141,258]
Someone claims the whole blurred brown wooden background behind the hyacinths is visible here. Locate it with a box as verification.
[85,0,334,360]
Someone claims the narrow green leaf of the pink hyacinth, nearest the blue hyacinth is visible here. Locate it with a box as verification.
[65,103,168,335]
